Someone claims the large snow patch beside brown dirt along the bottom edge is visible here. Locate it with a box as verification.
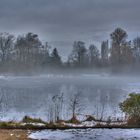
[29,129,140,140]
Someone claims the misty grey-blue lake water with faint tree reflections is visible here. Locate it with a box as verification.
[0,74,140,120]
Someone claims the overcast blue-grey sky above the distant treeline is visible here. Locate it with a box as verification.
[0,0,140,57]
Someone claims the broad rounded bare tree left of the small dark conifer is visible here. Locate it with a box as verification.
[15,33,41,65]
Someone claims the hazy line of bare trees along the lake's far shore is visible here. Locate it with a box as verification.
[0,28,140,72]
